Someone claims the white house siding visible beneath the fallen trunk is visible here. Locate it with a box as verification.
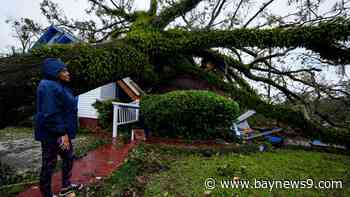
[78,87,101,119]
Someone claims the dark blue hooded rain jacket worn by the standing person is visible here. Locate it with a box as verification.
[35,58,78,142]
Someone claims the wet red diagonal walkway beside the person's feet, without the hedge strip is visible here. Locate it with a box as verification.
[18,140,139,197]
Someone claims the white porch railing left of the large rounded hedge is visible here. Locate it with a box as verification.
[112,100,140,138]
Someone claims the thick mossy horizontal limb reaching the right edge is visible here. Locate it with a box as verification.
[164,20,350,64]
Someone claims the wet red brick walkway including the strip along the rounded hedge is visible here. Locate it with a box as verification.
[18,130,224,197]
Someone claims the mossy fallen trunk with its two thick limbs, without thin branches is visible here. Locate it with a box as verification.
[0,22,350,143]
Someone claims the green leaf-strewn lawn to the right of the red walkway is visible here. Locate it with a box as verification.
[79,144,350,197]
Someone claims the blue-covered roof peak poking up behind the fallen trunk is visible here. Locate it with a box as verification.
[32,25,78,49]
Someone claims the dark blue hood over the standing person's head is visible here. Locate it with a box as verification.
[41,58,67,80]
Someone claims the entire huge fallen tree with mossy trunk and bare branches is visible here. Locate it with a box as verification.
[0,0,350,144]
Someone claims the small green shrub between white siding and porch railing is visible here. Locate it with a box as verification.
[92,99,119,129]
